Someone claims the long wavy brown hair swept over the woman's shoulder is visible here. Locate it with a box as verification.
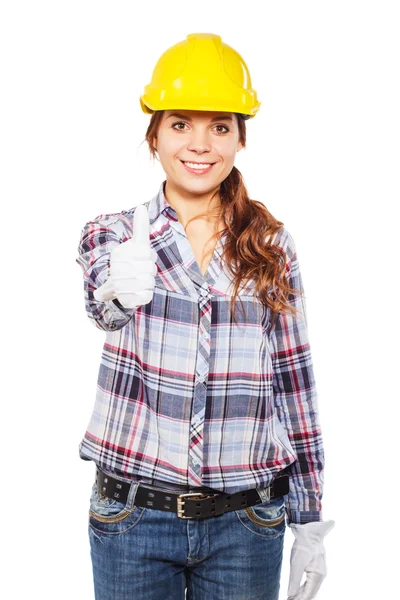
[144,110,301,326]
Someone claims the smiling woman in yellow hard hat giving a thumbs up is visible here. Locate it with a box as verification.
[77,34,334,600]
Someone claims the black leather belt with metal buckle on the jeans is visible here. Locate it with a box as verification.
[96,466,289,519]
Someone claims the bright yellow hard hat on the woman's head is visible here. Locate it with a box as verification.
[139,33,261,119]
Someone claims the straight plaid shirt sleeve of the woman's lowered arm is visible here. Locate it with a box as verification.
[270,230,325,524]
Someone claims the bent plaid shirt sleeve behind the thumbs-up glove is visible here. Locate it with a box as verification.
[76,215,137,331]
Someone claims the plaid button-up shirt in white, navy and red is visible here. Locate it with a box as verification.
[76,182,324,524]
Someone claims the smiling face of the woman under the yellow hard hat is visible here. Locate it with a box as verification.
[154,109,243,194]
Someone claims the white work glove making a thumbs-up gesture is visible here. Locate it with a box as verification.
[94,204,157,308]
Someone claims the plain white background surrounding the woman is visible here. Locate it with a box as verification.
[0,0,400,600]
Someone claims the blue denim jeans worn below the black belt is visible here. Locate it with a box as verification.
[88,482,286,600]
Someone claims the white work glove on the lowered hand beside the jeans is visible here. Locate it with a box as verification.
[287,520,335,600]
